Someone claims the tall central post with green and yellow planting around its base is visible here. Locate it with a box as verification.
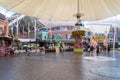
[72,0,85,53]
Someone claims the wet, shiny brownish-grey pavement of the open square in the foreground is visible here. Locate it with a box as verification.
[0,51,120,80]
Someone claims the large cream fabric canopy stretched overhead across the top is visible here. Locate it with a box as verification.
[0,0,120,21]
